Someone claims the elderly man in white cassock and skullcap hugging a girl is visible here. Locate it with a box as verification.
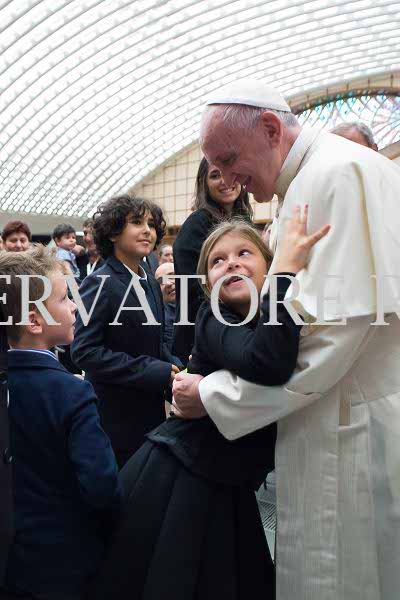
[173,80,400,600]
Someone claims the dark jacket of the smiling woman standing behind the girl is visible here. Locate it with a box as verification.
[172,208,217,365]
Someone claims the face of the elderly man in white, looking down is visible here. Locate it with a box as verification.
[202,107,282,202]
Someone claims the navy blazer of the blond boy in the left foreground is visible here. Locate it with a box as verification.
[6,350,119,598]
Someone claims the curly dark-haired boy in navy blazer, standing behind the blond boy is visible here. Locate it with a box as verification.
[71,195,179,467]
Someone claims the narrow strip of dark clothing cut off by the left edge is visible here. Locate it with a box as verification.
[0,328,13,588]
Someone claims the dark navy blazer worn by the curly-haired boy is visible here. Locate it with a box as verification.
[71,256,171,466]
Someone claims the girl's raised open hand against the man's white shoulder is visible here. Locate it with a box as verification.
[274,204,331,273]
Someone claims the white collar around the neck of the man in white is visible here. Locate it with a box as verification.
[275,127,321,202]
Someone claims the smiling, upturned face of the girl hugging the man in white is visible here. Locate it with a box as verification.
[207,233,267,315]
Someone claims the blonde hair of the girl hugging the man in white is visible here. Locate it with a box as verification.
[197,219,272,298]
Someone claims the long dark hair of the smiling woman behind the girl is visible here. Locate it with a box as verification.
[192,157,253,220]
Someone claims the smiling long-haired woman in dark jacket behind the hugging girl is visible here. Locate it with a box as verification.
[172,158,253,364]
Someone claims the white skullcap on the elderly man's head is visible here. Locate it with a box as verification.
[206,79,291,112]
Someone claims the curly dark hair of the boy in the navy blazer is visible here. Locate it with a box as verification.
[93,194,166,258]
